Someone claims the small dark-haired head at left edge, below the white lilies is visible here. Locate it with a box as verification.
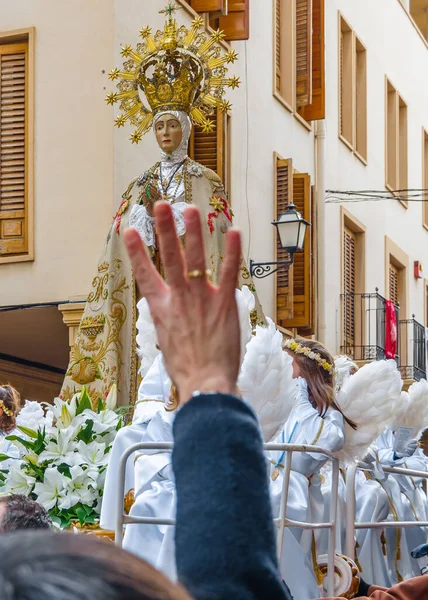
[0,494,52,533]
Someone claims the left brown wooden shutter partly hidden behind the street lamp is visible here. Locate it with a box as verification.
[274,158,293,327]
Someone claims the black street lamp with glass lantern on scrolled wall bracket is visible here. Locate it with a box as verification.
[250,204,311,279]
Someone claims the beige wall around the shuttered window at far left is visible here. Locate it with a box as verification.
[0,0,113,305]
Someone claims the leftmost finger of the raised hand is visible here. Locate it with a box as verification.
[123,229,166,299]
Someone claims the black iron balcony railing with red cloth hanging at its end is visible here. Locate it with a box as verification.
[341,288,400,364]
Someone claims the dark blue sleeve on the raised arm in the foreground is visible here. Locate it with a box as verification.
[172,394,291,600]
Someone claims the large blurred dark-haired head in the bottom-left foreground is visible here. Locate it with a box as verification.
[0,531,191,600]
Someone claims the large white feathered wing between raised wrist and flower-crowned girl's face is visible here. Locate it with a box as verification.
[238,319,297,442]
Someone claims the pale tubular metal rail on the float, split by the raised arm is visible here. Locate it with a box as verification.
[115,442,339,596]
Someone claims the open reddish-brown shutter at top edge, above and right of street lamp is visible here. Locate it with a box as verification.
[298,0,325,121]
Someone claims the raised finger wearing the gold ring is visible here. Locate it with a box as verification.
[184,206,207,287]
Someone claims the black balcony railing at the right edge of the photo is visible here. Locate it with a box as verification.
[399,315,427,381]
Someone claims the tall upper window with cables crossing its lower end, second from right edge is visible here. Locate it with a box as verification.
[385,79,408,208]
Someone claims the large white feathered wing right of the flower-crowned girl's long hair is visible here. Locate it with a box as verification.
[336,360,403,462]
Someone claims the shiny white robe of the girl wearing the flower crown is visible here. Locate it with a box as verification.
[270,377,345,600]
